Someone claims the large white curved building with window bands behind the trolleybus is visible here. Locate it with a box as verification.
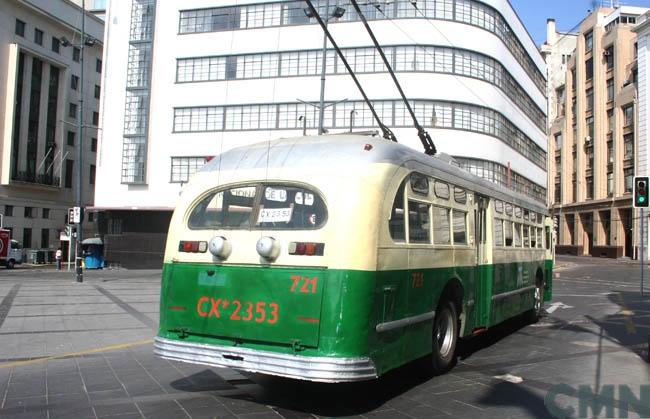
[95,0,547,264]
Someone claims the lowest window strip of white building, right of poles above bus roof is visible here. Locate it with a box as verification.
[455,157,546,202]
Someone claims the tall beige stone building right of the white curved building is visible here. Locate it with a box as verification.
[548,6,647,257]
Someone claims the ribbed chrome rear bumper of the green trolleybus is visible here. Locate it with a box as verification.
[154,337,377,383]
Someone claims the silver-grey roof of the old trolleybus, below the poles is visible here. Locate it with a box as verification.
[201,134,548,214]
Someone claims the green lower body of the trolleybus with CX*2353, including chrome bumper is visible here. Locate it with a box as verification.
[155,261,552,382]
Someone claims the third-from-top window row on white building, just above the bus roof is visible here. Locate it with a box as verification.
[173,100,546,169]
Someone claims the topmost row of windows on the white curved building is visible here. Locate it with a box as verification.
[179,0,546,94]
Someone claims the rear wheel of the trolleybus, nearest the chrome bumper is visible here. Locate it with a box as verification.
[431,300,458,375]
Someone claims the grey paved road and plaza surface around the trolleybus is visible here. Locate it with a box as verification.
[0,257,650,419]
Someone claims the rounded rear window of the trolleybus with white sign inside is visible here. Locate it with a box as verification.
[188,184,327,230]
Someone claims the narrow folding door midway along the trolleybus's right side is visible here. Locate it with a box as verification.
[474,195,493,328]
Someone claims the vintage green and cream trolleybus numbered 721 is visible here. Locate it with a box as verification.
[154,134,553,382]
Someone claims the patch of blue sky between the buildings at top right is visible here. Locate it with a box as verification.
[510,0,650,46]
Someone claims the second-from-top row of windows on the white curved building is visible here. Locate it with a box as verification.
[176,45,546,131]
